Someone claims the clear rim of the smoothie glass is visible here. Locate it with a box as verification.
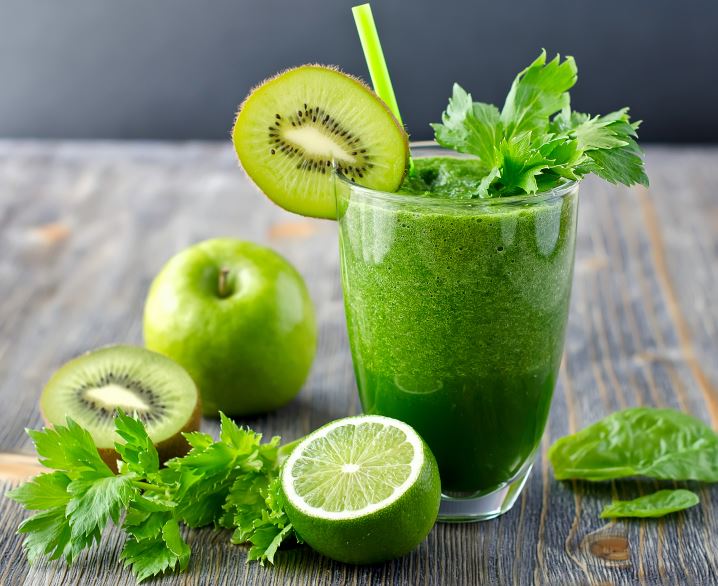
[334,140,580,209]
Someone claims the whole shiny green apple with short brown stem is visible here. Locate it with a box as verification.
[144,238,317,416]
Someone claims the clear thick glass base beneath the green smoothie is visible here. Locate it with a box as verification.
[438,458,533,523]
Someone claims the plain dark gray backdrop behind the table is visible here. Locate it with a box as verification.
[0,0,718,142]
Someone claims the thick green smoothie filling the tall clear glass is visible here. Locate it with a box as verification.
[338,158,577,493]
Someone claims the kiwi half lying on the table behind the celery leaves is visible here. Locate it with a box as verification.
[40,346,201,470]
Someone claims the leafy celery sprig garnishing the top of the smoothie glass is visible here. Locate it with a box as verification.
[434,51,648,198]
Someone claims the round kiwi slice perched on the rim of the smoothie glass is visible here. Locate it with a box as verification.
[232,65,409,219]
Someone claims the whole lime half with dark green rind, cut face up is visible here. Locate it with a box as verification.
[282,415,441,564]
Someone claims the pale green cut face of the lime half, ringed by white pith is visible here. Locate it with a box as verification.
[282,415,426,520]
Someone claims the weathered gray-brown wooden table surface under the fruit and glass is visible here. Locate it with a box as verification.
[0,142,718,585]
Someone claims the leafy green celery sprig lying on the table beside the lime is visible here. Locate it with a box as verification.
[8,412,299,582]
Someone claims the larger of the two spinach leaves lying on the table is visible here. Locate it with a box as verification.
[548,407,718,482]
